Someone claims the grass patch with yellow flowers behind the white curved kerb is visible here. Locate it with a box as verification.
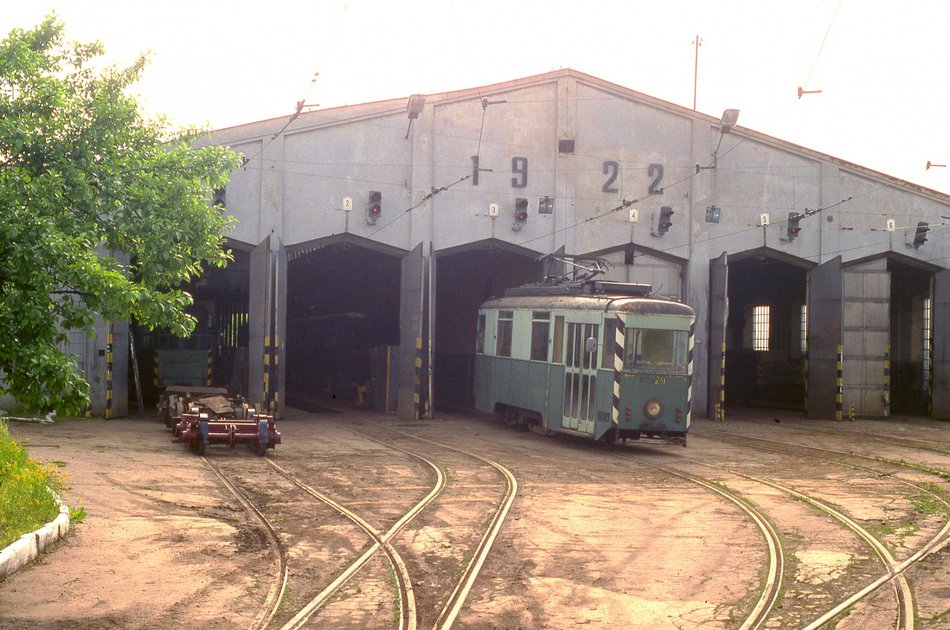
[0,420,67,548]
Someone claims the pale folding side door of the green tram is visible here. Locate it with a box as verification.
[562,322,600,434]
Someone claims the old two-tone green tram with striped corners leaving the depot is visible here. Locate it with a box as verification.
[475,280,696,446]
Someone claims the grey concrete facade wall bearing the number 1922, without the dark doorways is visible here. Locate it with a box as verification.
[152,70,950,417]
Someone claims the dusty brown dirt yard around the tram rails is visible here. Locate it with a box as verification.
[0,410,950,628]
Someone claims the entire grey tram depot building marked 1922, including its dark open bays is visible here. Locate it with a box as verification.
[74,69,950,419]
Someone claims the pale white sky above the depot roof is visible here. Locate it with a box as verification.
[0,0,950,193]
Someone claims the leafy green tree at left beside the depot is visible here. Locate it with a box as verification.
[0,16,238,414]
